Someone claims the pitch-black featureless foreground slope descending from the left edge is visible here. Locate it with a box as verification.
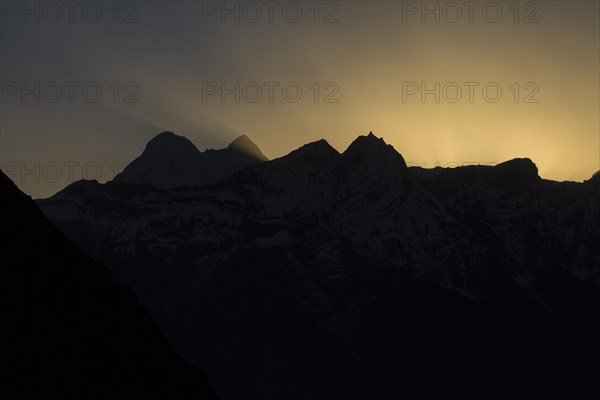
[0,173,216,399]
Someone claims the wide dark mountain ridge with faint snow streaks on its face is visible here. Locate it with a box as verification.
[38,134,600,400]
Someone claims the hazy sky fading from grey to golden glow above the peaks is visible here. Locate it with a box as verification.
[0,0,600,198]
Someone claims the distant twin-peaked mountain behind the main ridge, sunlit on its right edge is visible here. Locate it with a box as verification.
[114,132,267,188]
